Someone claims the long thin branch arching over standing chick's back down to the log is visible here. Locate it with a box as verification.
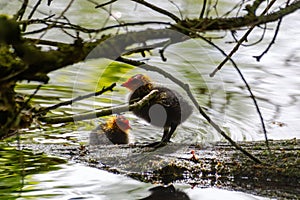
[117,57,262,163]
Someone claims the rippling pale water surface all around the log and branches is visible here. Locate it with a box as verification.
[0,1,300,199]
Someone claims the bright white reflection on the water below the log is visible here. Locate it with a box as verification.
[20,164,267,200]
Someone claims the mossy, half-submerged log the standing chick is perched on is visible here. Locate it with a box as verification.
[27,139,300,199]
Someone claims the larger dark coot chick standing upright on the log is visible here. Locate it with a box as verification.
[122,74,192,146]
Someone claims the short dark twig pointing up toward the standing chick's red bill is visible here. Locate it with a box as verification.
[38,83,117,114]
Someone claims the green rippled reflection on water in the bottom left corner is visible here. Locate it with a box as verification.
[0,143,66,199]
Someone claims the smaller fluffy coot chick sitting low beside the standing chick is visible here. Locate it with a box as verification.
[89,115,130,145]
